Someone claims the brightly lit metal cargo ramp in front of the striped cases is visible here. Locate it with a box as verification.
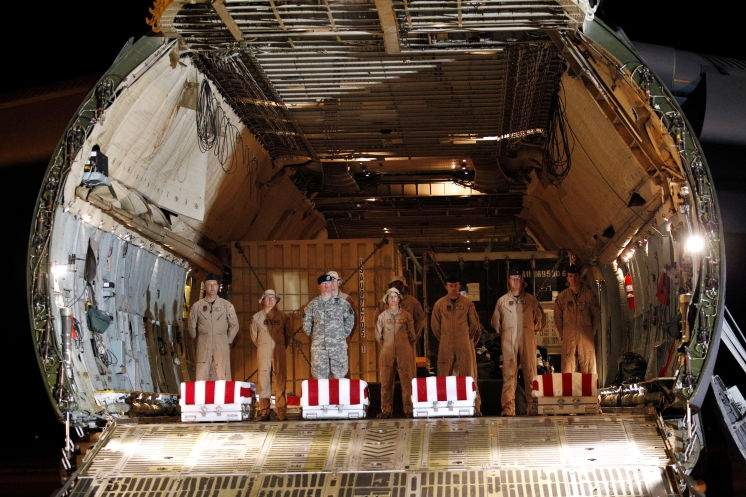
[63,414,678,497]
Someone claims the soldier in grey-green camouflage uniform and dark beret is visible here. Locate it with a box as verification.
[303,274,355,378]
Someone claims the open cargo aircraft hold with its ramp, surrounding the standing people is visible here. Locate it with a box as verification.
[28,0,725,497]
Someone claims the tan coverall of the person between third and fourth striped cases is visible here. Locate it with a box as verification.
[492,292,545,416]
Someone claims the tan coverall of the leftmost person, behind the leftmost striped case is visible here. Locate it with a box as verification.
[189,297,238,380]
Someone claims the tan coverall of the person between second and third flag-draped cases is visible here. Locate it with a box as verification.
[376,309,417,416]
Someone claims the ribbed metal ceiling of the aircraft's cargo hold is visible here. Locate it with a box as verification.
[155,0,583,247]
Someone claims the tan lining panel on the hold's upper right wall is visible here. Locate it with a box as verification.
[521,74,662,262]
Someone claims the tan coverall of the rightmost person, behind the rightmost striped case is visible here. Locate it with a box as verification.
[554,285,600,374]
